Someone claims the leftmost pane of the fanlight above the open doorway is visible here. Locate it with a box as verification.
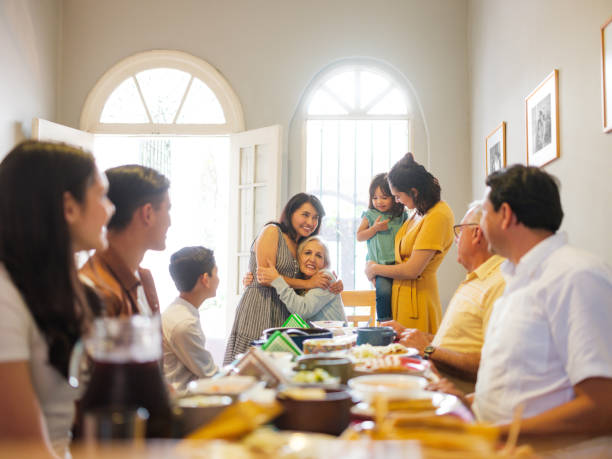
[100,77,149,123]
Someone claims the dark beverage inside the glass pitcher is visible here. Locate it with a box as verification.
[81,361,172,438]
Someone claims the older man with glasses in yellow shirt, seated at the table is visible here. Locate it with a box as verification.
[381,202,505,391]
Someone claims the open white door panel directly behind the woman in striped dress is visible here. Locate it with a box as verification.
[226,125,281,330]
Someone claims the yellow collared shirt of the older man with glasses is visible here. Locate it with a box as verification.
[431,255,506,354]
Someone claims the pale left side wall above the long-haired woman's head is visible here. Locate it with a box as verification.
[0,0,61,159]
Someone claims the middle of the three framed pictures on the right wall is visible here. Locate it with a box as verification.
[525,69,559,167]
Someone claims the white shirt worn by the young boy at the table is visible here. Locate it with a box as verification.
[162,297,217,391]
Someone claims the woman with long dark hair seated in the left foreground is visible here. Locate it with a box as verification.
[0,141,114,457]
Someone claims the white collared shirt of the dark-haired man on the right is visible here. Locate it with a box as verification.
[473,234,612,424]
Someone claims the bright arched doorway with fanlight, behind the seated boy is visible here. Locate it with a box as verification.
[80,51,244,356]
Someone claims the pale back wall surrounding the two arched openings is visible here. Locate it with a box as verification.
[59,0,471,310]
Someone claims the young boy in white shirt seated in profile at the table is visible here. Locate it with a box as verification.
[162,247,219,391]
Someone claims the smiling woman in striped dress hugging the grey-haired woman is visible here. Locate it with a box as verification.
[223,193,330,365]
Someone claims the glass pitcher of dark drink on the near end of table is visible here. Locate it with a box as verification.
[70,315,172,437]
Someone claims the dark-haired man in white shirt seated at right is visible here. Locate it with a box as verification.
[440,165,612,435]
